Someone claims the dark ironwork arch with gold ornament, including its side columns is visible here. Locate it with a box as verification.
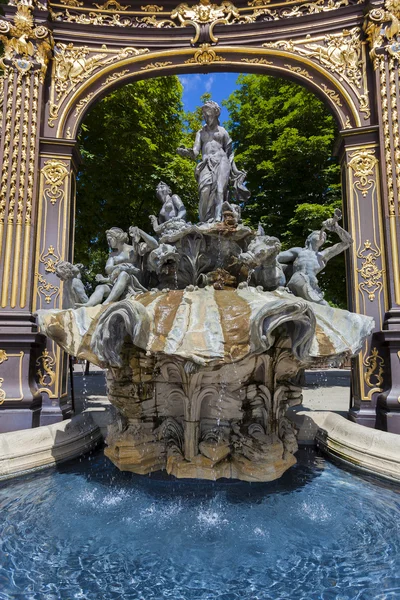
[0,0,400,432]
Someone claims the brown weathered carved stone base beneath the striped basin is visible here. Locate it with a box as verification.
[105,346,301,481]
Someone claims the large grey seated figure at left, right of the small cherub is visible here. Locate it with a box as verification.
[78,227,158,306]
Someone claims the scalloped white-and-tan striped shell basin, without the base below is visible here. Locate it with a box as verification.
[38,287,374,366]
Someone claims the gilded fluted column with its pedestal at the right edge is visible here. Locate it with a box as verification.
[365,0,400,433]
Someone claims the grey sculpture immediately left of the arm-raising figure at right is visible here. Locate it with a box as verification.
[239,225,285,291]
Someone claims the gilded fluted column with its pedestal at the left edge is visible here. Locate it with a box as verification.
[0,3,52,432]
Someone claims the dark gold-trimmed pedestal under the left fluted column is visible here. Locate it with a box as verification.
[0,313,45,433]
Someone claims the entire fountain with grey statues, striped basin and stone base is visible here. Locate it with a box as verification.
[39,102,373,481]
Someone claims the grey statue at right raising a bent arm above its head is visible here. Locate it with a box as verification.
[278,209,353,304]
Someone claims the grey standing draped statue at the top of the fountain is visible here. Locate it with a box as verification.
[177,100,250,223]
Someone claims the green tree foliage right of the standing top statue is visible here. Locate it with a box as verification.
[224,75,346,306]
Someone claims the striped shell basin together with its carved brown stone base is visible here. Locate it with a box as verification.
[39,286,374,481]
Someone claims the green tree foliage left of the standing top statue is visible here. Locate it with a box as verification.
[75,77,197,279]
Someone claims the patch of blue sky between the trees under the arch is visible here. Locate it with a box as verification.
[179,73,239,124]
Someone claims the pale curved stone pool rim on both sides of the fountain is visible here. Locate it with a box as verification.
[0,408,400,483]
